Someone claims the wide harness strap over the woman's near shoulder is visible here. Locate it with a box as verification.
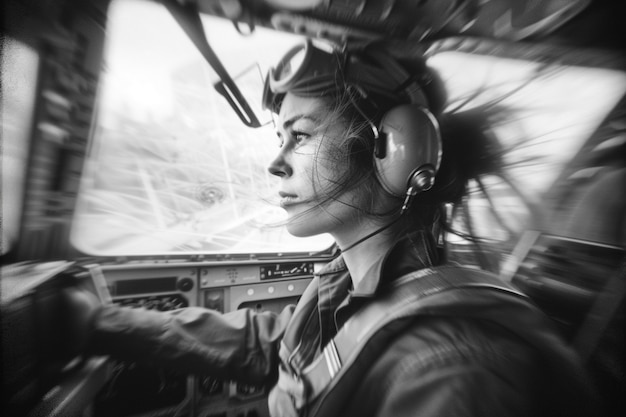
[296,266,526,415]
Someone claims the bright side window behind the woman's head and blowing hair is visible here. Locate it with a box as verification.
[429,51,626,253]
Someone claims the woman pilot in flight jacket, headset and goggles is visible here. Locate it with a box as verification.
[69,42,592,417]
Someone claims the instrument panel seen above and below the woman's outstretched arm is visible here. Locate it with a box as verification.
[92,260,325,417]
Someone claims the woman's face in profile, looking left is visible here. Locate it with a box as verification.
[269,93,359,237]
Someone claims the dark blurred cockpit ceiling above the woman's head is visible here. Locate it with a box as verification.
[186,0,625,47]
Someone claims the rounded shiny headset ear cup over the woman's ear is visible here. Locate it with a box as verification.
[374,104,441,197]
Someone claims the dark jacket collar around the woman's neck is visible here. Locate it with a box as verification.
[318,231,438,297]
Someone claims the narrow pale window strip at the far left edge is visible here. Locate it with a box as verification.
[0,37,39,254]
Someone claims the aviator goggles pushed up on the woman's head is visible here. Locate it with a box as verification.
[262,40,428,111]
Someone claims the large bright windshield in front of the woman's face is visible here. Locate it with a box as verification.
[72,0,332,256]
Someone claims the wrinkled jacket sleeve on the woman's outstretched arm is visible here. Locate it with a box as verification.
[89,306,293,384]
